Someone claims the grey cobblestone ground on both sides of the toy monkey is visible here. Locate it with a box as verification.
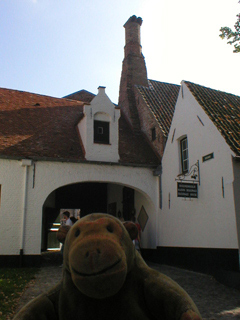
[13,263,240,320]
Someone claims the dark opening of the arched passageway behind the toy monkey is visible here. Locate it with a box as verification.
[41,182,139,251]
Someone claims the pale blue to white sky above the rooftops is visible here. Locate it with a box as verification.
[0,0,240,103]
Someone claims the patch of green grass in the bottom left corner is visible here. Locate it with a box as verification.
[0,268,38,320]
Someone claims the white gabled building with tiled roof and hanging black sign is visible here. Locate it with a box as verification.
[158,81,240,269]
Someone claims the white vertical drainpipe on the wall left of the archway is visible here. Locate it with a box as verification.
[19,159,32,268]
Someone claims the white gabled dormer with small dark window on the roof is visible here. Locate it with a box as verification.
[78,87,120,162]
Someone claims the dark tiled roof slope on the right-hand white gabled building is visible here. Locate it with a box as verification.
[184,81,240,156]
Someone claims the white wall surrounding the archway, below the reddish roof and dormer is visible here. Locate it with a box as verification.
[0,160,157,255]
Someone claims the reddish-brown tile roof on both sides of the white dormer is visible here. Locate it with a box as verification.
[0,88,159,166]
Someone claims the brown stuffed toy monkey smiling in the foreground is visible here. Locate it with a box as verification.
[14,213,202,320]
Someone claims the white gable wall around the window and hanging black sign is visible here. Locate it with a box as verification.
[158,82,238,248]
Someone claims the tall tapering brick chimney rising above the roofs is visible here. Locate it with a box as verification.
[118,16,148,131]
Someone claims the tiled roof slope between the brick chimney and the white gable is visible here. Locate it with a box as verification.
[136,80,180,137]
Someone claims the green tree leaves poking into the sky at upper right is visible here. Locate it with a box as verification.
[219,1,240,53]
